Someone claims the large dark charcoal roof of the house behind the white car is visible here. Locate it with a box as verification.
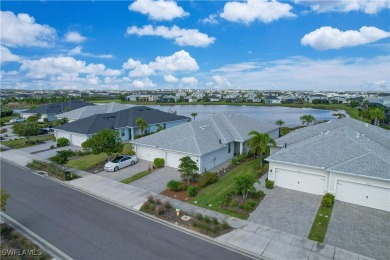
[55,106,191,134]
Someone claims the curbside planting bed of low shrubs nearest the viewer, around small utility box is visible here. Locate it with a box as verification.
[140,196,233,237]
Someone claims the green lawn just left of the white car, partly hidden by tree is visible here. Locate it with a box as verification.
[66,144,131,171]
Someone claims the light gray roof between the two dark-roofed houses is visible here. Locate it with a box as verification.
[56,102,130,123]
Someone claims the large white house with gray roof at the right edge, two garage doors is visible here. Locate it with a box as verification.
[267,118,390,211]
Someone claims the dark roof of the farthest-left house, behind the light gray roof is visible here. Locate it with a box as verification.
[23,100,94,114]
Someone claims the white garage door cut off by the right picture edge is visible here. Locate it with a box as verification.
[336,180,390,211]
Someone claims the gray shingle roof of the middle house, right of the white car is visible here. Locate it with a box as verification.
[133,112,278,155]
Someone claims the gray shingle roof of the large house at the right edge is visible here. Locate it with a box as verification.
[267,118,390,180]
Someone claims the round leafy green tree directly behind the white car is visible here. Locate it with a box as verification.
[81,128,123,161]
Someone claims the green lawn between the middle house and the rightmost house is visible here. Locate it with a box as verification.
[188,159,260,219]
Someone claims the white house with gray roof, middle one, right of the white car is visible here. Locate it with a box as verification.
[132,112,279,173]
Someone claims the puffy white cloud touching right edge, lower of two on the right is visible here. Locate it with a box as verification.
[301,26,390,50]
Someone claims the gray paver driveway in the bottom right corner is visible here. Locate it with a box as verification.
[325,201,390,260]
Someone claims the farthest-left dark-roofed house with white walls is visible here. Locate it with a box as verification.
[20,100,95,121]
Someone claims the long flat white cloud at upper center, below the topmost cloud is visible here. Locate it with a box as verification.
[127,25,215,47]
